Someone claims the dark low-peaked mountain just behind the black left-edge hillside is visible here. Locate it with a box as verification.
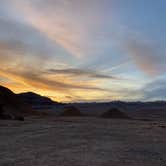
[18,92,61,106]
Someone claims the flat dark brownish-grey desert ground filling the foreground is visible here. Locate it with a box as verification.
[0,117,166,166]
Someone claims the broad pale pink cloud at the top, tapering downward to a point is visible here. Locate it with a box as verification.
[8,0,113,57]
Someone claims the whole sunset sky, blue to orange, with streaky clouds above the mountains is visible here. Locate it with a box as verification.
[0,0,166,102]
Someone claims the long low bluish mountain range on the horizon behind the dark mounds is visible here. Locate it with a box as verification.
[72,101,166,120]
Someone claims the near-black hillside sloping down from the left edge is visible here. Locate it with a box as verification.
[0,86,35,116]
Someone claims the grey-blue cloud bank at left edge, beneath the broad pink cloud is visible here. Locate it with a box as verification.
[0,17,72,69]
